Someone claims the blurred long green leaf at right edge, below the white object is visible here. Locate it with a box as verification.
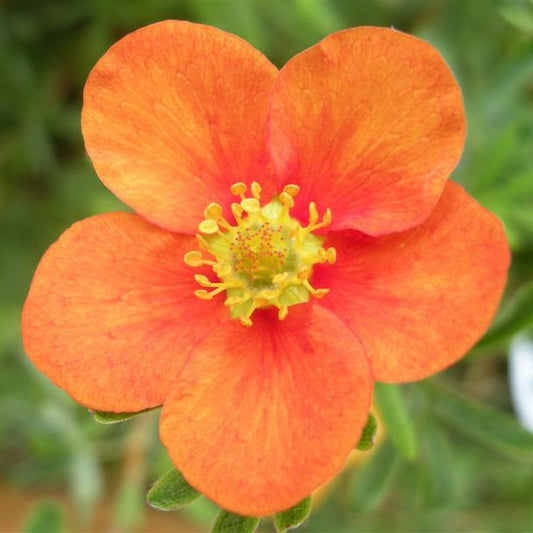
[420,382,533,464]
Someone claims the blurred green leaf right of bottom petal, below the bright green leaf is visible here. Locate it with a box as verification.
[350,440,398,512]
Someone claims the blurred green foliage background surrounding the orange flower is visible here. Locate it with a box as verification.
[0,0,533,533]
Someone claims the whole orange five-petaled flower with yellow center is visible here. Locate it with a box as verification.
[23,21,509,515]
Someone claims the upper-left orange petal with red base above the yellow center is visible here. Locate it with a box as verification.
[82,20,277,233]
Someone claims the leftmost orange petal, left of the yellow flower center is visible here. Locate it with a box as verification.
[22,213,222,411]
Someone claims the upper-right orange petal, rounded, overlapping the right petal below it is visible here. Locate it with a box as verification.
[269,27,465,235]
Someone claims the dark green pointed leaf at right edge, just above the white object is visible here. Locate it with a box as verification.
[476,282,533,348]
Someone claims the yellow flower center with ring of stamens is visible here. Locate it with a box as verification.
[184,182,336,326]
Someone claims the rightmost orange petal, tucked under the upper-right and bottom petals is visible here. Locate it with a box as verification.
[313,182,509,383]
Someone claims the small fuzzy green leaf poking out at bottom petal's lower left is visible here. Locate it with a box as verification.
[146,469,201,511]
